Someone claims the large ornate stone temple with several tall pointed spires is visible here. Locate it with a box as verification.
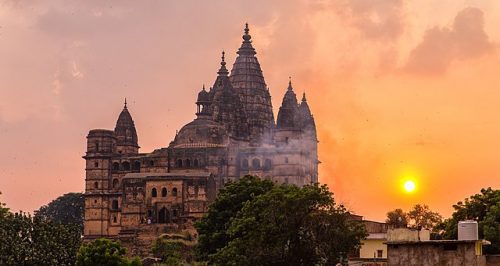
[83,25,319,243]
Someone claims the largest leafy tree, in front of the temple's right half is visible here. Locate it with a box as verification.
[210,185,366,265]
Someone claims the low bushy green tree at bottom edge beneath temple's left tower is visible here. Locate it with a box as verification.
[76,238,141,266]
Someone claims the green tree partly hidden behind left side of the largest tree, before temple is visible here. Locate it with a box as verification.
[195,176,274,260]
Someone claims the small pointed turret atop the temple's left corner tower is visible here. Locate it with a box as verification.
[115,99,139,154]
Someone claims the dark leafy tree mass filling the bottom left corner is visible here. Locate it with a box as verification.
[0,212,81,265]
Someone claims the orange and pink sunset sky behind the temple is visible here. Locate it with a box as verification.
[0,0,500,221]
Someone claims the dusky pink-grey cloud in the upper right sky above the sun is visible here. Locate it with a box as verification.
[404,7,494,75]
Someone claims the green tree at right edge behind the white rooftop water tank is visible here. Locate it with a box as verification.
[443,188,500,254]
